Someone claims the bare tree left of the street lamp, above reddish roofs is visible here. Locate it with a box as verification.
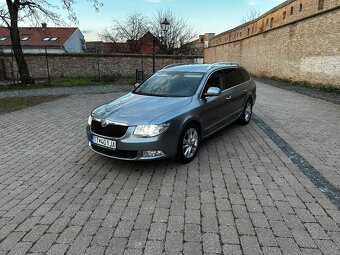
[99,11,149,53]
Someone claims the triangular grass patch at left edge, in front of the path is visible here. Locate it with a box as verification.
[0,96,65,114]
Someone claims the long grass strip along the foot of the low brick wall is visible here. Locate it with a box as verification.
[0,78,135,91]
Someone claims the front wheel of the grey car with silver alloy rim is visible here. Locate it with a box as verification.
[176,123,200,164]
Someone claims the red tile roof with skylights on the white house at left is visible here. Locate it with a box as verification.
[0,27,77,47]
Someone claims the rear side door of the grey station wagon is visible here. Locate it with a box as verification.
[222,68,246,123]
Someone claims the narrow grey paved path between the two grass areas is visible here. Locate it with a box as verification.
[0,85,133,98]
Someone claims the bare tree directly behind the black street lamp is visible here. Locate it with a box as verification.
[151,9,197,54]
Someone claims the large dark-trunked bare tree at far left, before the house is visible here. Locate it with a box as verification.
[0,0,102,84]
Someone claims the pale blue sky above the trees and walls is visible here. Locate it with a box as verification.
[17,0,283,41]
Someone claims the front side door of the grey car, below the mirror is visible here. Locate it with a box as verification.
[200,70,226,135]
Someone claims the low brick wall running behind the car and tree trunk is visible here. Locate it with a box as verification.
[0,54,199,79]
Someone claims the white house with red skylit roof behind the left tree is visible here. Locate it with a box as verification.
[0,23,86,54]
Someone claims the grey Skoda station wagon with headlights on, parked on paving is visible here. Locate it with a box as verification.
[87,63,256,163]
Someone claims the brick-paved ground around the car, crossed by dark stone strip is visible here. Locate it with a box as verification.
[0,84,340,255]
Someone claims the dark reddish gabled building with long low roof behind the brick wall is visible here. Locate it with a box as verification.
[86,32,161,54]
